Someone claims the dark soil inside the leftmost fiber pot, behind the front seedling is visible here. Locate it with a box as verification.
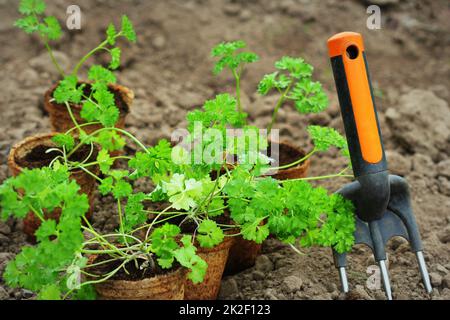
[15,145,97,169]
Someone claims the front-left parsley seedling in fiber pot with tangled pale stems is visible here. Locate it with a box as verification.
[0,161,207,299]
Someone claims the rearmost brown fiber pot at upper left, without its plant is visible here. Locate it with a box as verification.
[44,82,134,133]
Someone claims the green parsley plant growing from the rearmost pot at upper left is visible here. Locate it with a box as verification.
[15,0,137,151]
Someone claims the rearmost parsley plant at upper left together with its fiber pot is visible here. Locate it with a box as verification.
[15,0,136,151]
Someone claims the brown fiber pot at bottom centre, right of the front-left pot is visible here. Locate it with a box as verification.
[184,237,234,300]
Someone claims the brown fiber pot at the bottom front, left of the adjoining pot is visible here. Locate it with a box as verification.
[95,268,186,300]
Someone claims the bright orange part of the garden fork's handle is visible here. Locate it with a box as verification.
[328,32,383,164]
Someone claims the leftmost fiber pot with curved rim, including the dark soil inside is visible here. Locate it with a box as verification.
[8,133,99,241]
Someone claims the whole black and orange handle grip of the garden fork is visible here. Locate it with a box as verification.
[328,32,387,177]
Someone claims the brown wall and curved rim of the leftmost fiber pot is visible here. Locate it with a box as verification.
[8,133,99,241]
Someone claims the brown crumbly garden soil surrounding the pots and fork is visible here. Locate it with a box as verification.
[0,0,450,299]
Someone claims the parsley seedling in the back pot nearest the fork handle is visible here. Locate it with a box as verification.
[212,41,348,180]
